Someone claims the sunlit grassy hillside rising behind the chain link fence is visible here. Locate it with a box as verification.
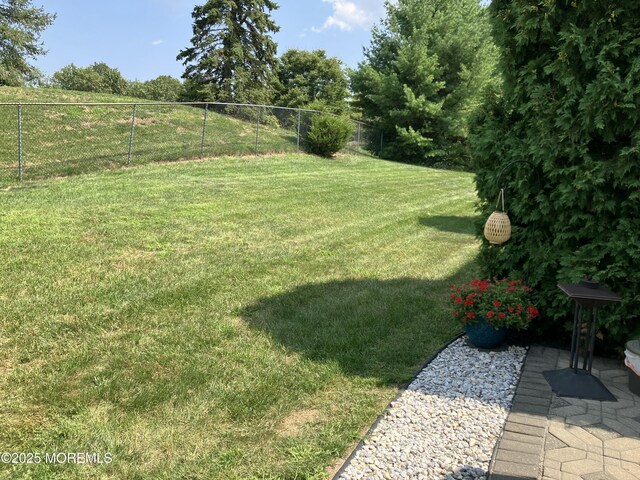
[0,87,297,183]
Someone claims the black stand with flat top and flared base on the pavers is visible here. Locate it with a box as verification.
[542,280,622,402]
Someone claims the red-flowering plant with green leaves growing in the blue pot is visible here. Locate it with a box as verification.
[450,279,539,330]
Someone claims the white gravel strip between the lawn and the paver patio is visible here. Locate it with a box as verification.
[339,338,526,480]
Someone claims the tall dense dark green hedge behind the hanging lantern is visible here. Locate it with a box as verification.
[470,0,640,351]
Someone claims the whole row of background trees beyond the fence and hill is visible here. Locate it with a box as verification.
[0,0,499,167]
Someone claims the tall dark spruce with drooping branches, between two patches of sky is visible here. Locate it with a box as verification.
[177,0,279,103]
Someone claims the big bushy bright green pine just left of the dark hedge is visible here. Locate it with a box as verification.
[351,0,497,164]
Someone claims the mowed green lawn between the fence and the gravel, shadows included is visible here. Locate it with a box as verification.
[0,155,478,479]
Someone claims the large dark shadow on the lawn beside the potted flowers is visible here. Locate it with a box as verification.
[241,278,470,385]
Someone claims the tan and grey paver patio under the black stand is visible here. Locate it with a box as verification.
[489,346,640,480]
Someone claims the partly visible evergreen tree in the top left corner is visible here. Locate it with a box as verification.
[0,0,55,86]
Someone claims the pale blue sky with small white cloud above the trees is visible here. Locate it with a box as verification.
[33,0,385,80]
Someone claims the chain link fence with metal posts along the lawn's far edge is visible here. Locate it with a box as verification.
[0,103,382,183]
